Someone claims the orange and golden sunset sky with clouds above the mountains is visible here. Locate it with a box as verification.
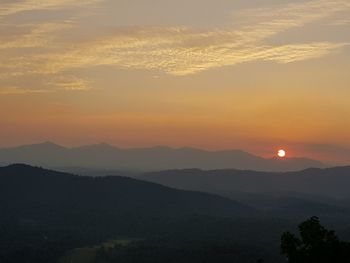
[0,0,350,164]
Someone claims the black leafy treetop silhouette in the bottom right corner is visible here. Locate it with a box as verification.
[281,217,350,263]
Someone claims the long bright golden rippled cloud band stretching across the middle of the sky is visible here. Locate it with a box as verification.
[2,29,348,78]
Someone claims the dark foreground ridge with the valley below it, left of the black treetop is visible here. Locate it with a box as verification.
[0,164,350,263]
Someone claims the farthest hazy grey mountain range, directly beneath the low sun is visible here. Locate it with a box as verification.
[0,142,324,171]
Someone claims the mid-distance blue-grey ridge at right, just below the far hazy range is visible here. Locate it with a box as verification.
[144,167,350,198]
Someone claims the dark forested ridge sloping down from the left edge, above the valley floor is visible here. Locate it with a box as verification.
[0,165,253,222]
